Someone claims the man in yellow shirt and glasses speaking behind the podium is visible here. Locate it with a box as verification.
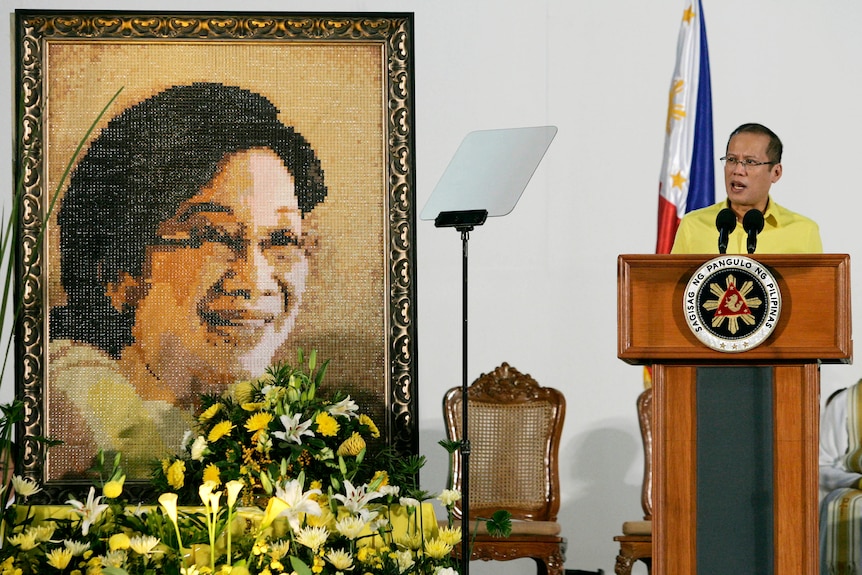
[671,124,823,254]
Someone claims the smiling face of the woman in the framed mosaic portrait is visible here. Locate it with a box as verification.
[120,148,308,394]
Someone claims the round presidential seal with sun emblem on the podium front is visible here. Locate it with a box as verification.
[683,256,781,353]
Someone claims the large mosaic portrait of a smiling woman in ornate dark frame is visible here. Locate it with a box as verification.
[16,10,418,501]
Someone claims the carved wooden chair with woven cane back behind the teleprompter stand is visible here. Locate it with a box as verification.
[443,363,566,575]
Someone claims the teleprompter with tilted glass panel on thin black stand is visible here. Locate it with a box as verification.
[420,126,557,575]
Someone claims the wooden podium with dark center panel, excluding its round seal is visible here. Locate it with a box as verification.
[617,254,852,575]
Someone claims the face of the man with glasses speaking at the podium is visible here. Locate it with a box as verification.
[724,132,781,216]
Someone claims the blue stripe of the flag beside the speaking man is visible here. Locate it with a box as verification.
[685,1,715,212]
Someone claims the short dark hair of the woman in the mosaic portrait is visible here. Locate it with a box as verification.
[50,83,327,357]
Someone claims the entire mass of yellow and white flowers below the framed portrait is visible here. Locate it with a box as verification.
[0,352,472,575]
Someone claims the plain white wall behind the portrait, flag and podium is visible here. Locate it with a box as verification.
[0,0,862,574]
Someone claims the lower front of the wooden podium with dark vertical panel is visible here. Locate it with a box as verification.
[653,364,819,575]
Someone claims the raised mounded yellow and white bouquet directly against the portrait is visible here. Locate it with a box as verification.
[153,350,388,505]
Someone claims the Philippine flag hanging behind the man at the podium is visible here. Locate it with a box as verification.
[655,0,715,254]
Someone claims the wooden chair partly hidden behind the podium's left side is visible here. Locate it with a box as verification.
[614,388,652,575]
